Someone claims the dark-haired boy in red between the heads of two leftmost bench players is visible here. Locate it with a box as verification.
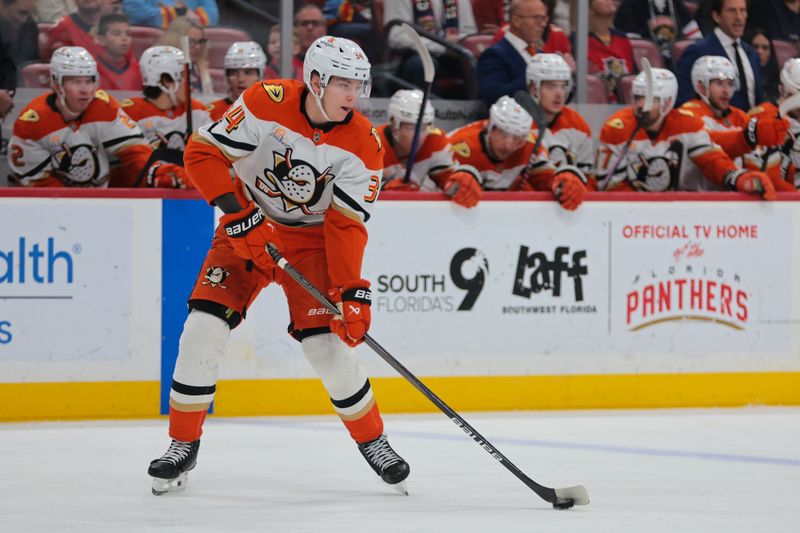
[95,14,142,91]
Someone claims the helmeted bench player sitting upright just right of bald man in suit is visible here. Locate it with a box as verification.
[525,54,596,183]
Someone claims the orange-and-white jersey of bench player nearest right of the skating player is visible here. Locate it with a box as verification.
[378,124,457,191]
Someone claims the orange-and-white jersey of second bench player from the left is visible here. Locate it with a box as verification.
[119,96,211,150]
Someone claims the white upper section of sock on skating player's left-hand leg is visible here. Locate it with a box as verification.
[173,310,231,395]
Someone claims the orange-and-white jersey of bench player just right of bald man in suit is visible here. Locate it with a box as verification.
[534,107,594,177]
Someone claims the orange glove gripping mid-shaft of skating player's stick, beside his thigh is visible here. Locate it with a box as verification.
[328,279,372,348]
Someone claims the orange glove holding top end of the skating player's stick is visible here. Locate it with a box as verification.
[219,200,283,271]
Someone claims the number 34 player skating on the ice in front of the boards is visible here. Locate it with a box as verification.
[148,37,410,494]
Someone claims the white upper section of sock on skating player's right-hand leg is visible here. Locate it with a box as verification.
[301,333,372,405]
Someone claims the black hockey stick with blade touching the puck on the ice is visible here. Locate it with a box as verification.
[267,244,589,509]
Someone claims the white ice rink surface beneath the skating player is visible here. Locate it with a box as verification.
[0,408,800,533]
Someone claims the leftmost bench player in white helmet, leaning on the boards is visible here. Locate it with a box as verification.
[8,46,177,187]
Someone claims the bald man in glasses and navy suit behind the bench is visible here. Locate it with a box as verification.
[478,0,548,106]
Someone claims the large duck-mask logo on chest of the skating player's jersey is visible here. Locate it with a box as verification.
[256,148,335,215]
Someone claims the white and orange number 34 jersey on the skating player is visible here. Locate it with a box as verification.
[189,80,384,286]
